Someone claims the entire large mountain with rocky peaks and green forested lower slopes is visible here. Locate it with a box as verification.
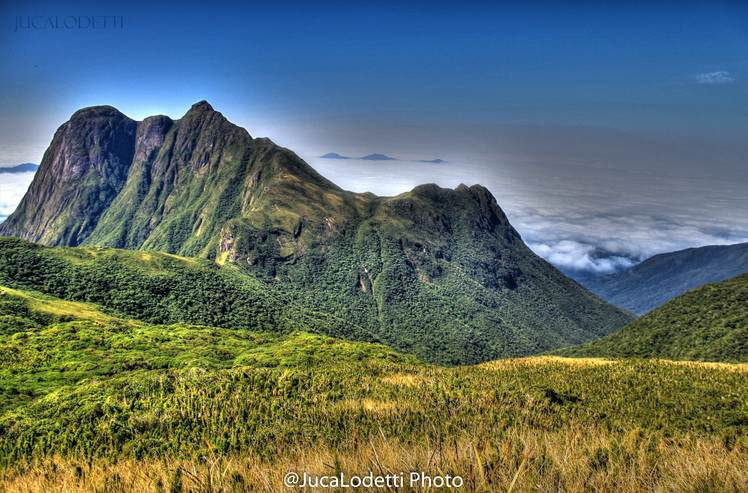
[0,101,631,364]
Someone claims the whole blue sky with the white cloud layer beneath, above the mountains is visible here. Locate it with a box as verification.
[0,0,748,275]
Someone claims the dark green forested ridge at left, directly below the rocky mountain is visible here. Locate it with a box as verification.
[0,238,374,341]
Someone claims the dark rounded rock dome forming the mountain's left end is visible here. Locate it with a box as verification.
[0,106,137,246]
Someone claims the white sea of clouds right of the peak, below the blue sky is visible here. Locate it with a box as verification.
[310,135,748,279]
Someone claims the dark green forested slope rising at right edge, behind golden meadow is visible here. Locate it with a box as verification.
[556,274,748,363]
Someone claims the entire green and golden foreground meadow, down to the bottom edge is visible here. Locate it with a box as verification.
[0,278,748,493]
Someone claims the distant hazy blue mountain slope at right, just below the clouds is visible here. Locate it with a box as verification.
[580,243,748,316]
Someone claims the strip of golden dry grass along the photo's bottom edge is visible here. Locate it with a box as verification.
[0,427,748,493]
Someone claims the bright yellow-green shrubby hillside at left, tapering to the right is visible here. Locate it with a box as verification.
[0,287,417,415]
